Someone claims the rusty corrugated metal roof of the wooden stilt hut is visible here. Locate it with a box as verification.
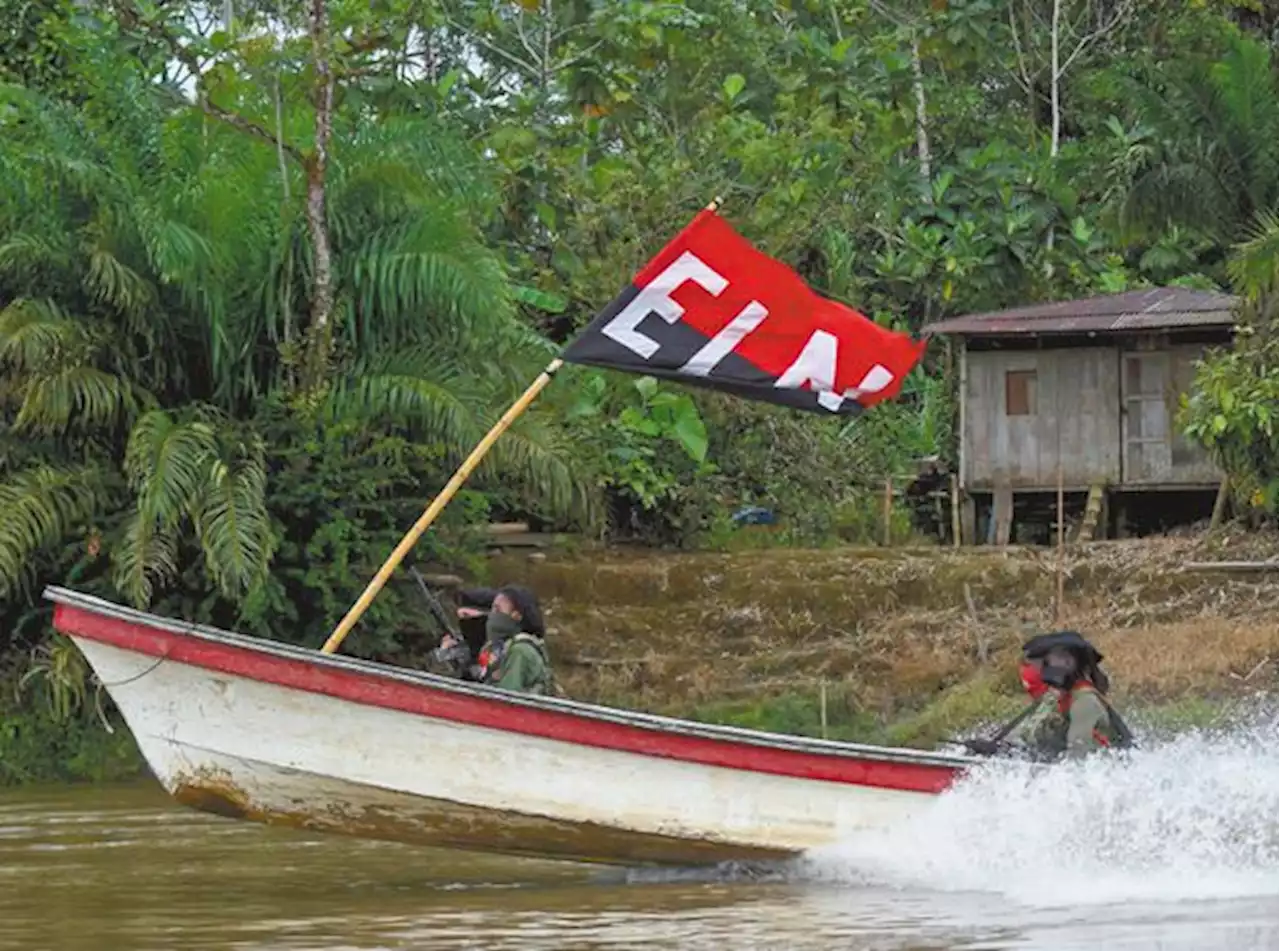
[923,287,1239,337]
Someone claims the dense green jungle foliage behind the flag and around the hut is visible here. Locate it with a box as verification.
[0,0,1280,757]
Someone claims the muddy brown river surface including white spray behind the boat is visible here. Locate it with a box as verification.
[0,726,1280,951]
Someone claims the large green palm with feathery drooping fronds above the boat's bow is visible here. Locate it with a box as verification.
[0,76,593,614]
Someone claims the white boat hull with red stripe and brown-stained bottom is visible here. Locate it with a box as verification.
[47,583,965,865]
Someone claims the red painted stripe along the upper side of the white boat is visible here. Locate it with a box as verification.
[54,604,959,792]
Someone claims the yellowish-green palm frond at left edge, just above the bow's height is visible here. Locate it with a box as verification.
[0,465,109,600]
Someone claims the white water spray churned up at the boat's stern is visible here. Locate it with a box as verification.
[803,718,1280,907]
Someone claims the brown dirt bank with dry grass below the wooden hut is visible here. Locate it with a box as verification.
[483,534,1280,744]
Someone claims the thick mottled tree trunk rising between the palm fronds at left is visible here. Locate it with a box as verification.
[301,0,334,393]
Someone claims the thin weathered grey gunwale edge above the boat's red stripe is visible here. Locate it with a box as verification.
[44,585,982,771]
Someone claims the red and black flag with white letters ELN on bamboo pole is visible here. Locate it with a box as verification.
[561,210,925,415]
